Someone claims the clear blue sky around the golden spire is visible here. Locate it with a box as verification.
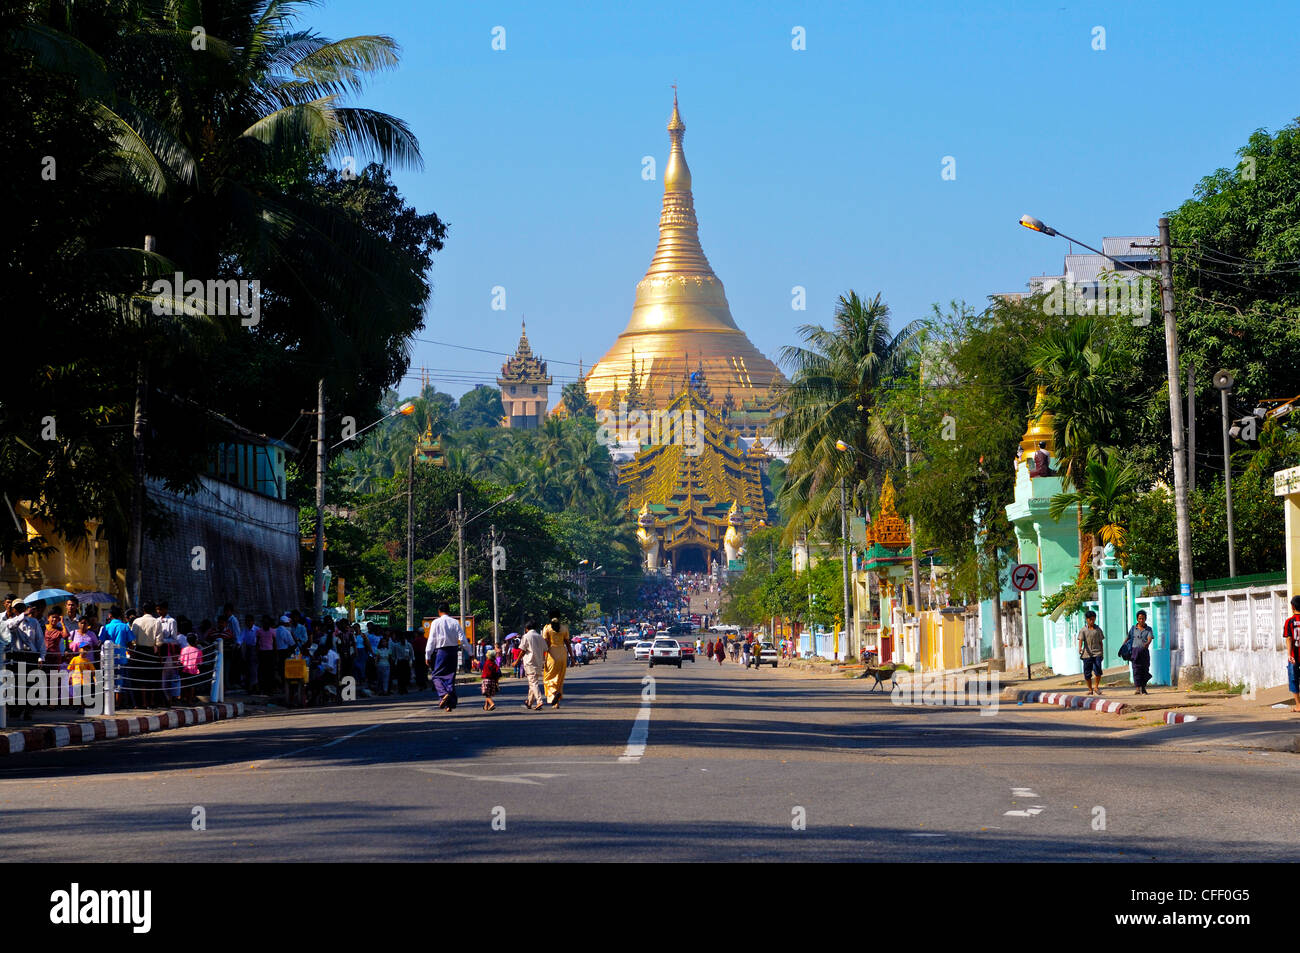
[303,0,1300,395]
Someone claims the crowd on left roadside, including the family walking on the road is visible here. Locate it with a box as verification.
[0,594,592,720]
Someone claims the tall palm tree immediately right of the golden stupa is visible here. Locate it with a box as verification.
[774,291,923,538]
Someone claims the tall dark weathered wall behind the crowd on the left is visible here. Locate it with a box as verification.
[140,476,307,624]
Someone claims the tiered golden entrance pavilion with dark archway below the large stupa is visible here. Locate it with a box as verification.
[619,387,767,572]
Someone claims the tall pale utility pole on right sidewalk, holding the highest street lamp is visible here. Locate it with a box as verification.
[1160,218,1201,685]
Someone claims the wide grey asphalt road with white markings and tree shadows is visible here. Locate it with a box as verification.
[0,651,1300,862]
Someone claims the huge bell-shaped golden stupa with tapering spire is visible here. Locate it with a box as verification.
[586,92,785,434]
